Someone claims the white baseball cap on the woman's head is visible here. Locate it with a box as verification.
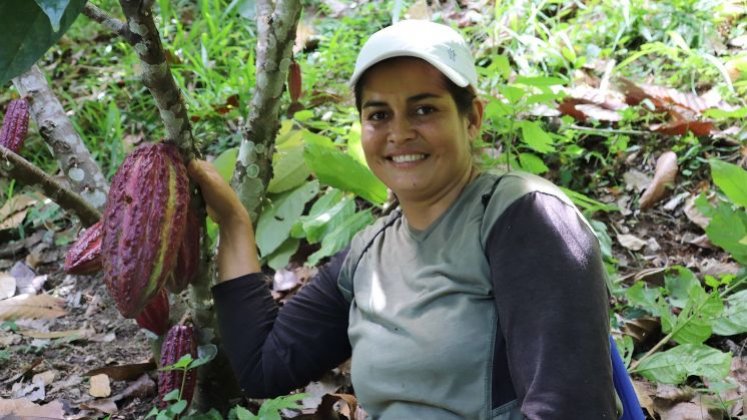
[350,20,477,89]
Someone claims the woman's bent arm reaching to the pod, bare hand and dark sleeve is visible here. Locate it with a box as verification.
[189,160,351,398]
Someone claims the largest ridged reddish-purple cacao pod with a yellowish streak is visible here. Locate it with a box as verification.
[101,143,189,318]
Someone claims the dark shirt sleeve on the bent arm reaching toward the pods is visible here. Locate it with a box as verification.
[212,250,351,398]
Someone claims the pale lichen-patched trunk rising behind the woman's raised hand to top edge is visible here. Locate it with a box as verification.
[231,0,301,223]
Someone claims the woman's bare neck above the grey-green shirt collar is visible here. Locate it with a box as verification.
[399,166,479,230]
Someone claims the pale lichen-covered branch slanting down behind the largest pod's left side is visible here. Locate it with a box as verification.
[13,65,109,210]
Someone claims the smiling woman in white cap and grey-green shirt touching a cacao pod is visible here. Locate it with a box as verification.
[190,21,617,419]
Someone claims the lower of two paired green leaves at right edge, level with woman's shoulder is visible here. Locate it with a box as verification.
[706,203,747,265]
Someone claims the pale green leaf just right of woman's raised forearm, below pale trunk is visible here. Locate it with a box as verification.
[256,180,319,258]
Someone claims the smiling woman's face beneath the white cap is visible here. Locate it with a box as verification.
[361,57,482,205]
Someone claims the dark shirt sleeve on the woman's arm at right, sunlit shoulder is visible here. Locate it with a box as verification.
[486,192,615,420]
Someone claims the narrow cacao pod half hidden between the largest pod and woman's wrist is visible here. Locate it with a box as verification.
[166,206,202,293]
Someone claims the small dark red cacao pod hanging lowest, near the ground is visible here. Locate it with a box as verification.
[158,325,197,407]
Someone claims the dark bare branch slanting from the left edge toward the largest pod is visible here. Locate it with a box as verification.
[0,146,101,226]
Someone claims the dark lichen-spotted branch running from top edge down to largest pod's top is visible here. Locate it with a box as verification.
[119,0,197,161]
